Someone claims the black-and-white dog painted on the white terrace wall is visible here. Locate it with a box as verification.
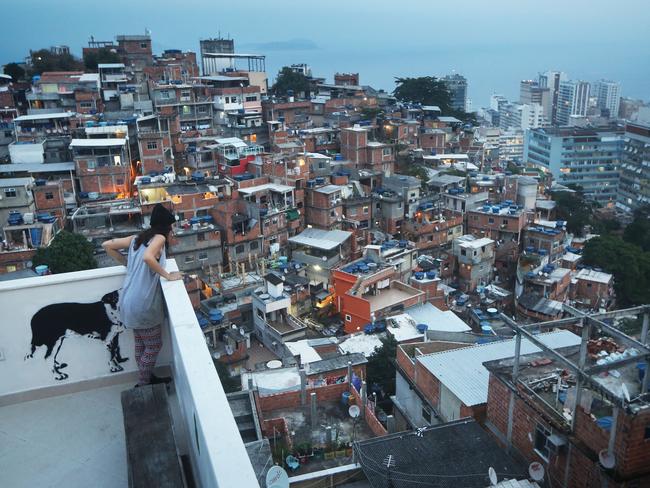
[25,290,129,380]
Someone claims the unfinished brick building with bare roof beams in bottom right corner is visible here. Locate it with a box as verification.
[484,311,650,488]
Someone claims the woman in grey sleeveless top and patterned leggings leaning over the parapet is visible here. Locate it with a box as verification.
[102,204,182,387]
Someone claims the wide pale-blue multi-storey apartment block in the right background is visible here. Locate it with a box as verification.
[524,125,624,206]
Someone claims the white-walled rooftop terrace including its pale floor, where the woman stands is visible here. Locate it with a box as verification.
[0,260,259,488]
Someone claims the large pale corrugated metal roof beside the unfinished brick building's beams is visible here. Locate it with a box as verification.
[418,330,580,407]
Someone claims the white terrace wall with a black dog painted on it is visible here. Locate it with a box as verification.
[0,266,171,397]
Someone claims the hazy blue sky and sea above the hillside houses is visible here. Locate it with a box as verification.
[0,0,650,108]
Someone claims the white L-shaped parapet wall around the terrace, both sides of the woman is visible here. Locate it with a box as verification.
[0,259,259,488]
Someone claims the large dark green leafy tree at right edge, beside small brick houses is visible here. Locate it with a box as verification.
[582,236,650,307]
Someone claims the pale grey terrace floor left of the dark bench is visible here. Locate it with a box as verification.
[0,383,133,488]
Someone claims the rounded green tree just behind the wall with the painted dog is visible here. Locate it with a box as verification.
[32,230,97,273]
